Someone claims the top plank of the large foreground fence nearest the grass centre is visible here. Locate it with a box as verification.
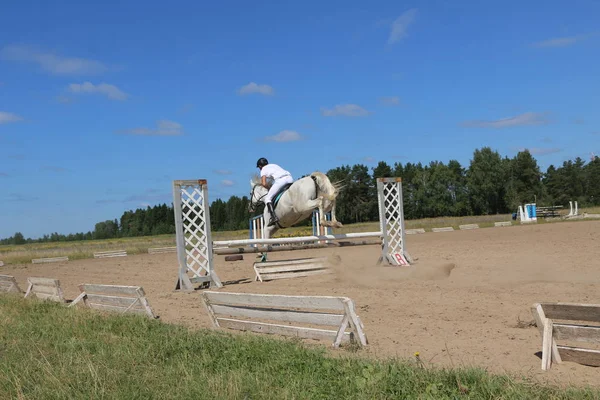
[202,290,347,311]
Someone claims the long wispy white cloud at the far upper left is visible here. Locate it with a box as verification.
[0,45,108,75]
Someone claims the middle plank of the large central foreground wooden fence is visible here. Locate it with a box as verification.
[212,304,344,327]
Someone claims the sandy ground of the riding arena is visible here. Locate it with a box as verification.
[0,221,600,386]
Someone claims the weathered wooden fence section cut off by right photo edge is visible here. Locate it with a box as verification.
[531,303,600,371]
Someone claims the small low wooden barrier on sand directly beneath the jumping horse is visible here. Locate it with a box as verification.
[254,257,330,282]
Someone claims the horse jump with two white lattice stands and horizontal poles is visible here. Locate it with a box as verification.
[173,177,411,291]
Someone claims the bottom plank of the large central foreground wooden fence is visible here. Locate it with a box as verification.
[217,318,350,341]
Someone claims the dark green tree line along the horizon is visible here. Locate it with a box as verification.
[0,147,600,244]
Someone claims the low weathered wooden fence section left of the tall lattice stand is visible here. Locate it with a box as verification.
[69,284,157,318]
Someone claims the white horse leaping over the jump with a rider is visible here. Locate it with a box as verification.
[249,172,342,238]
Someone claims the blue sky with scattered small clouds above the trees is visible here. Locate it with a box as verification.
[0,0,600,237]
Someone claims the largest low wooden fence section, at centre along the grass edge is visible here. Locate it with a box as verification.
[202,291,367,348]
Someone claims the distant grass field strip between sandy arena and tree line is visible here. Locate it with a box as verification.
[0,207,600,264]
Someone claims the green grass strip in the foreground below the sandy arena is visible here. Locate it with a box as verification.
[0,295,600,400]
